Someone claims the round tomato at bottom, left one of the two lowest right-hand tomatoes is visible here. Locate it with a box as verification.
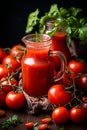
[52,107,69,124]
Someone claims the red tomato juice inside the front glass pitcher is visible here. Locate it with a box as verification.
[22,50,53,96]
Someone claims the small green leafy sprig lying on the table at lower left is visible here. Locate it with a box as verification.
[0,115,20,128]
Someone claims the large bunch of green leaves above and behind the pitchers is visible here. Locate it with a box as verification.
[25,4,87,44]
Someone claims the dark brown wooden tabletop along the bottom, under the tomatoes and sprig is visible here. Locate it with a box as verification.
[0,106,87,130]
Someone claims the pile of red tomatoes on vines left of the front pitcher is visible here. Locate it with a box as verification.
[0,44,26,110]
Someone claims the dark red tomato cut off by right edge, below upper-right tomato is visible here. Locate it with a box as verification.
[76,74,87,91]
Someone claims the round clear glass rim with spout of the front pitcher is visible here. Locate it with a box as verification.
[21,34,52,48]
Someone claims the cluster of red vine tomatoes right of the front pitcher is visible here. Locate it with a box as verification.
[48,59,87,124]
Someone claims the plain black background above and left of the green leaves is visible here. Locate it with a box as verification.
[0,0,87,47]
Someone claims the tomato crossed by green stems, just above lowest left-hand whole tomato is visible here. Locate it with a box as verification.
[0,77,18,95]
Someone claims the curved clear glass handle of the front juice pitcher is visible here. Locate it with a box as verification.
[49,50,67,82]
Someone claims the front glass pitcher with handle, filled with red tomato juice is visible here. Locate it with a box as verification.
[22,34,66,96]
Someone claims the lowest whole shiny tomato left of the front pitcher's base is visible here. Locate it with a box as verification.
[5,91,26,110]
